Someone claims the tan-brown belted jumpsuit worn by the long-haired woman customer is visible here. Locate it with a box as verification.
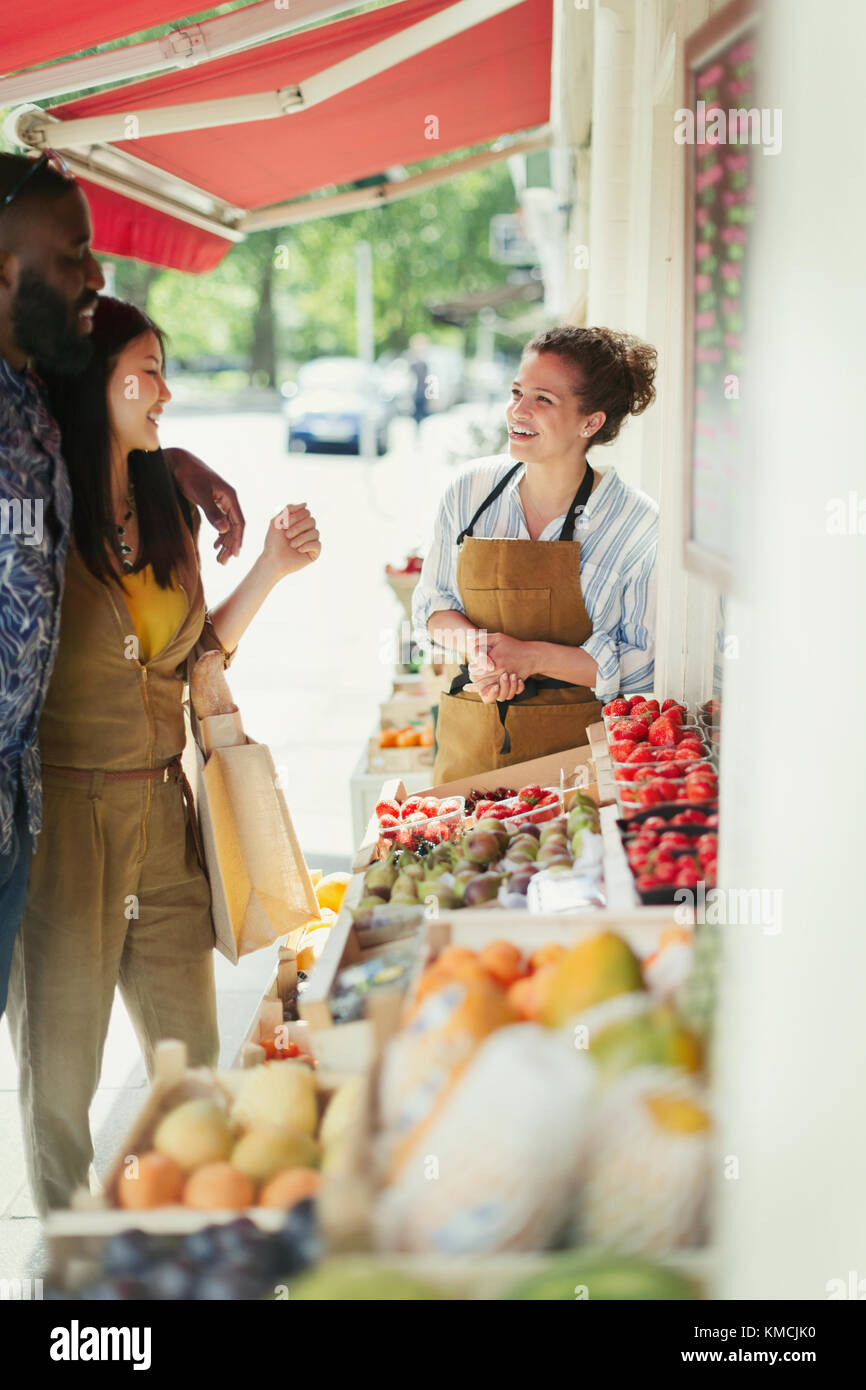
[8,513,220,1213]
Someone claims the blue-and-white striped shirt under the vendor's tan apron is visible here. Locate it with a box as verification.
[413,453,659,699]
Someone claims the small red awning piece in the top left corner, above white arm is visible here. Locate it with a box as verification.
[0,0,195,72]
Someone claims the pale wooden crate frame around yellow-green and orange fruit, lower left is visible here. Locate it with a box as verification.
[44,1024,370,1277]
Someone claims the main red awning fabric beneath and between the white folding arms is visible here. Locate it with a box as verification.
[42,0,552,271]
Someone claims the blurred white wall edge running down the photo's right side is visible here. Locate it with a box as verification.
[716,0,866,1301]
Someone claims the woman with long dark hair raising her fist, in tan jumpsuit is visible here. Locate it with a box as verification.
[8,297,320,1212]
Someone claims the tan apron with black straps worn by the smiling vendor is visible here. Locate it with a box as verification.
[434,463,602,785]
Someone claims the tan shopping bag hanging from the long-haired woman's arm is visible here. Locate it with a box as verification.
[185,713,321,963]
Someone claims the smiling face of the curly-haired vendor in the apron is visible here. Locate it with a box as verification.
[505,352,605,463]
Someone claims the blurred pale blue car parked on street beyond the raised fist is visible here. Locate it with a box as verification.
[281,357,393,453]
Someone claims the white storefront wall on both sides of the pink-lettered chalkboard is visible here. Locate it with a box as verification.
[559,0,866,1300]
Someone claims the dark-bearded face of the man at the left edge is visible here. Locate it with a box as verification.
[6,186,104,371]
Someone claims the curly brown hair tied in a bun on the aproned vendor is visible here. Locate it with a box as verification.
[524,327,657,448]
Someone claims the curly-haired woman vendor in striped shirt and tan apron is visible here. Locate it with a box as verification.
[413,328,657,784]
